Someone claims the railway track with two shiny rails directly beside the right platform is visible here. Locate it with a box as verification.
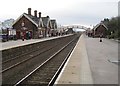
[14,34,78,86]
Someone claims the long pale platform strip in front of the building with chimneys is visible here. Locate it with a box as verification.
[0,34,72,50]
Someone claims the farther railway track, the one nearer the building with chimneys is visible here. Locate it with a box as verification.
[1,35,73,72]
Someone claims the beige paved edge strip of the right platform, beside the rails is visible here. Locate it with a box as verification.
[55,35,93,85]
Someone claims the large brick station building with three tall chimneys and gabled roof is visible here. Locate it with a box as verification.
[13,8,57,39]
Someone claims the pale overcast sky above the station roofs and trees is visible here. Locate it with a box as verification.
[0,0,119,26]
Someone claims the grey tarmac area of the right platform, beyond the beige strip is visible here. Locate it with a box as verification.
[84,36,118,84]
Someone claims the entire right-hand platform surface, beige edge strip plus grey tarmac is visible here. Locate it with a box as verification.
[55,35,118,86]
